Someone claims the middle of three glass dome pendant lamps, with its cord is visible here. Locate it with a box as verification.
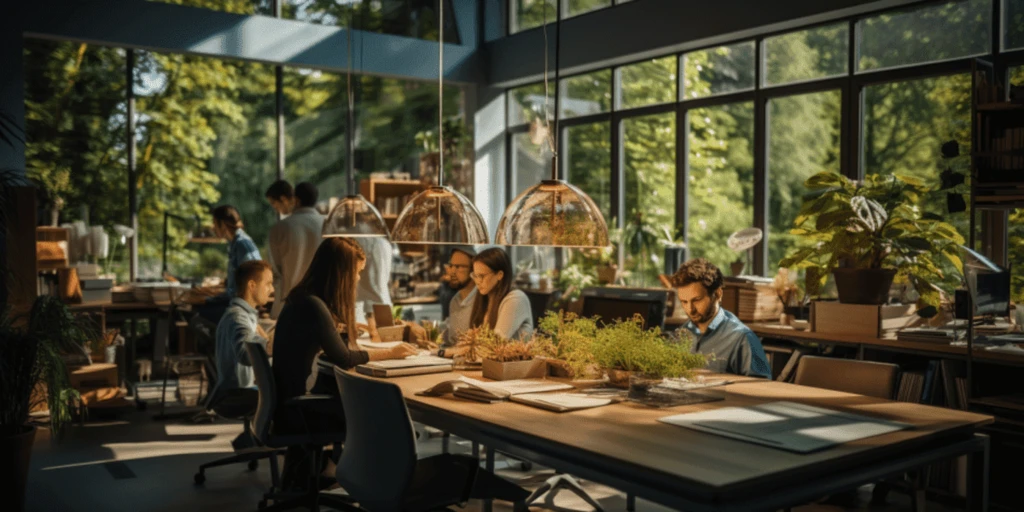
[391,0,490,245]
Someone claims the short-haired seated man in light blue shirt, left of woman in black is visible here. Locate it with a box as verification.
[216,260,273,394]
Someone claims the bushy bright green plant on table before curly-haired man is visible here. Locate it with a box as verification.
[591,315,707,388]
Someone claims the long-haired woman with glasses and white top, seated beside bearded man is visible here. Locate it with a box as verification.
[469,247,534,339]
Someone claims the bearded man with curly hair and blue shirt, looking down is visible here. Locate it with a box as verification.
[672,258,771,378]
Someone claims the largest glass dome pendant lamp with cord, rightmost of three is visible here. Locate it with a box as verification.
[495,0,608,248]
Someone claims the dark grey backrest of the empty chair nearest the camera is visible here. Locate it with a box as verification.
[334,367,417,512]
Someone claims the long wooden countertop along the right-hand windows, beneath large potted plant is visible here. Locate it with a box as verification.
[746,324,1024,366]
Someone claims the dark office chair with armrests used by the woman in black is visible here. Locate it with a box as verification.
[246,343,357,511]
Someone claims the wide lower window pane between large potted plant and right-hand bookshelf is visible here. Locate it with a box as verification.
[863,74,971,238]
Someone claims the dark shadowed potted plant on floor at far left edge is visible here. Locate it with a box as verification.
[0,296,93,511]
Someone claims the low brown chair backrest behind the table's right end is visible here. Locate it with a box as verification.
[794,355,899,399]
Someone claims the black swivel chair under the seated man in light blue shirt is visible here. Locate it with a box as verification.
[193,388,284,488]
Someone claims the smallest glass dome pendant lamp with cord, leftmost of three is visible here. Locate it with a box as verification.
[323,6,388,239]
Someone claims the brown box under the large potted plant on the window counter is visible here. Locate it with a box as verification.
[811,301,918,338]
